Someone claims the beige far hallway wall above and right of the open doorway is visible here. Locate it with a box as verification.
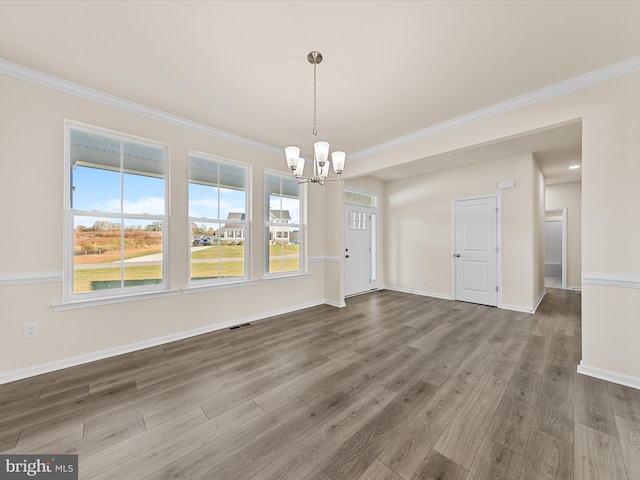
[545,182,582,289]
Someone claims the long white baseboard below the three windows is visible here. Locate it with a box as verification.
[0,300,330,385]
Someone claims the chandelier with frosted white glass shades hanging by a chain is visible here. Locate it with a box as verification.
[284,50,347,185]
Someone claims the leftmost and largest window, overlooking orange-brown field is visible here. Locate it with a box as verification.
[65,125,167,299]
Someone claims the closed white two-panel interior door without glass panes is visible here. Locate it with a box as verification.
[453,197,498,306]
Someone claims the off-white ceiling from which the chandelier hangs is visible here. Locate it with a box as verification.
[0,0,640,184]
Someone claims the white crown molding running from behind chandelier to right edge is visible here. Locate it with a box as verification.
[349,55,640,161]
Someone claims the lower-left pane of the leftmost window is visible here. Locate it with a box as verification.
[73,216,122,293]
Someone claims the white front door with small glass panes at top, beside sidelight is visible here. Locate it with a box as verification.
[344,205,377,296]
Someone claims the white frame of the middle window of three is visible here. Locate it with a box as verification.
[187,150,251,288]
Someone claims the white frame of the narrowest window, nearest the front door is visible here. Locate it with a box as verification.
[263,169,306,279]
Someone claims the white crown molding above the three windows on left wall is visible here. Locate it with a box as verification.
[0,58,282,155]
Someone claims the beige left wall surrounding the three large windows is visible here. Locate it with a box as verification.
[0,75,330,377]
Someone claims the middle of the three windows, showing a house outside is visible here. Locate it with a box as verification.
[189,153,249,284]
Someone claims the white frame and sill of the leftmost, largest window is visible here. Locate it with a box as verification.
[63,121,172,304]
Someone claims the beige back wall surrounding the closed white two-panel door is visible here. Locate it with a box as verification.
[384,154,544,310]
